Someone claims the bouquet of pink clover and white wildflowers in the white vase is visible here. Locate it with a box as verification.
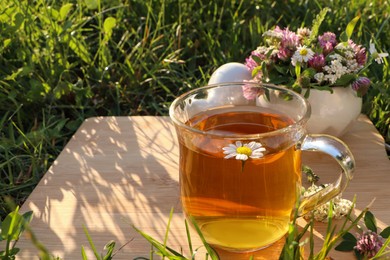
[245,9,388,96]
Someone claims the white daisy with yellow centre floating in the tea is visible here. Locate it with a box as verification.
[222,141,265,161]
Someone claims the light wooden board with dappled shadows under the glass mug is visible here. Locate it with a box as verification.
[13,116,390,259]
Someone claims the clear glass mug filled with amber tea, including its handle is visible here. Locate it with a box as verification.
[169,82,355,252]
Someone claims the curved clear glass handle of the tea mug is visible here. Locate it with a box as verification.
[298,134,355,216]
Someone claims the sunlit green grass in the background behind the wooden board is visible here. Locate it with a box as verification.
[0,0,390,218]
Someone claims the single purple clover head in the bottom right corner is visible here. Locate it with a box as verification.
[354,230,383,258]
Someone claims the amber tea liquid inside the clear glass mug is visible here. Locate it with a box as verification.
[179,108,301,251]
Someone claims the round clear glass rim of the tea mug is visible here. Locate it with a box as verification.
[169,82,311,140]
